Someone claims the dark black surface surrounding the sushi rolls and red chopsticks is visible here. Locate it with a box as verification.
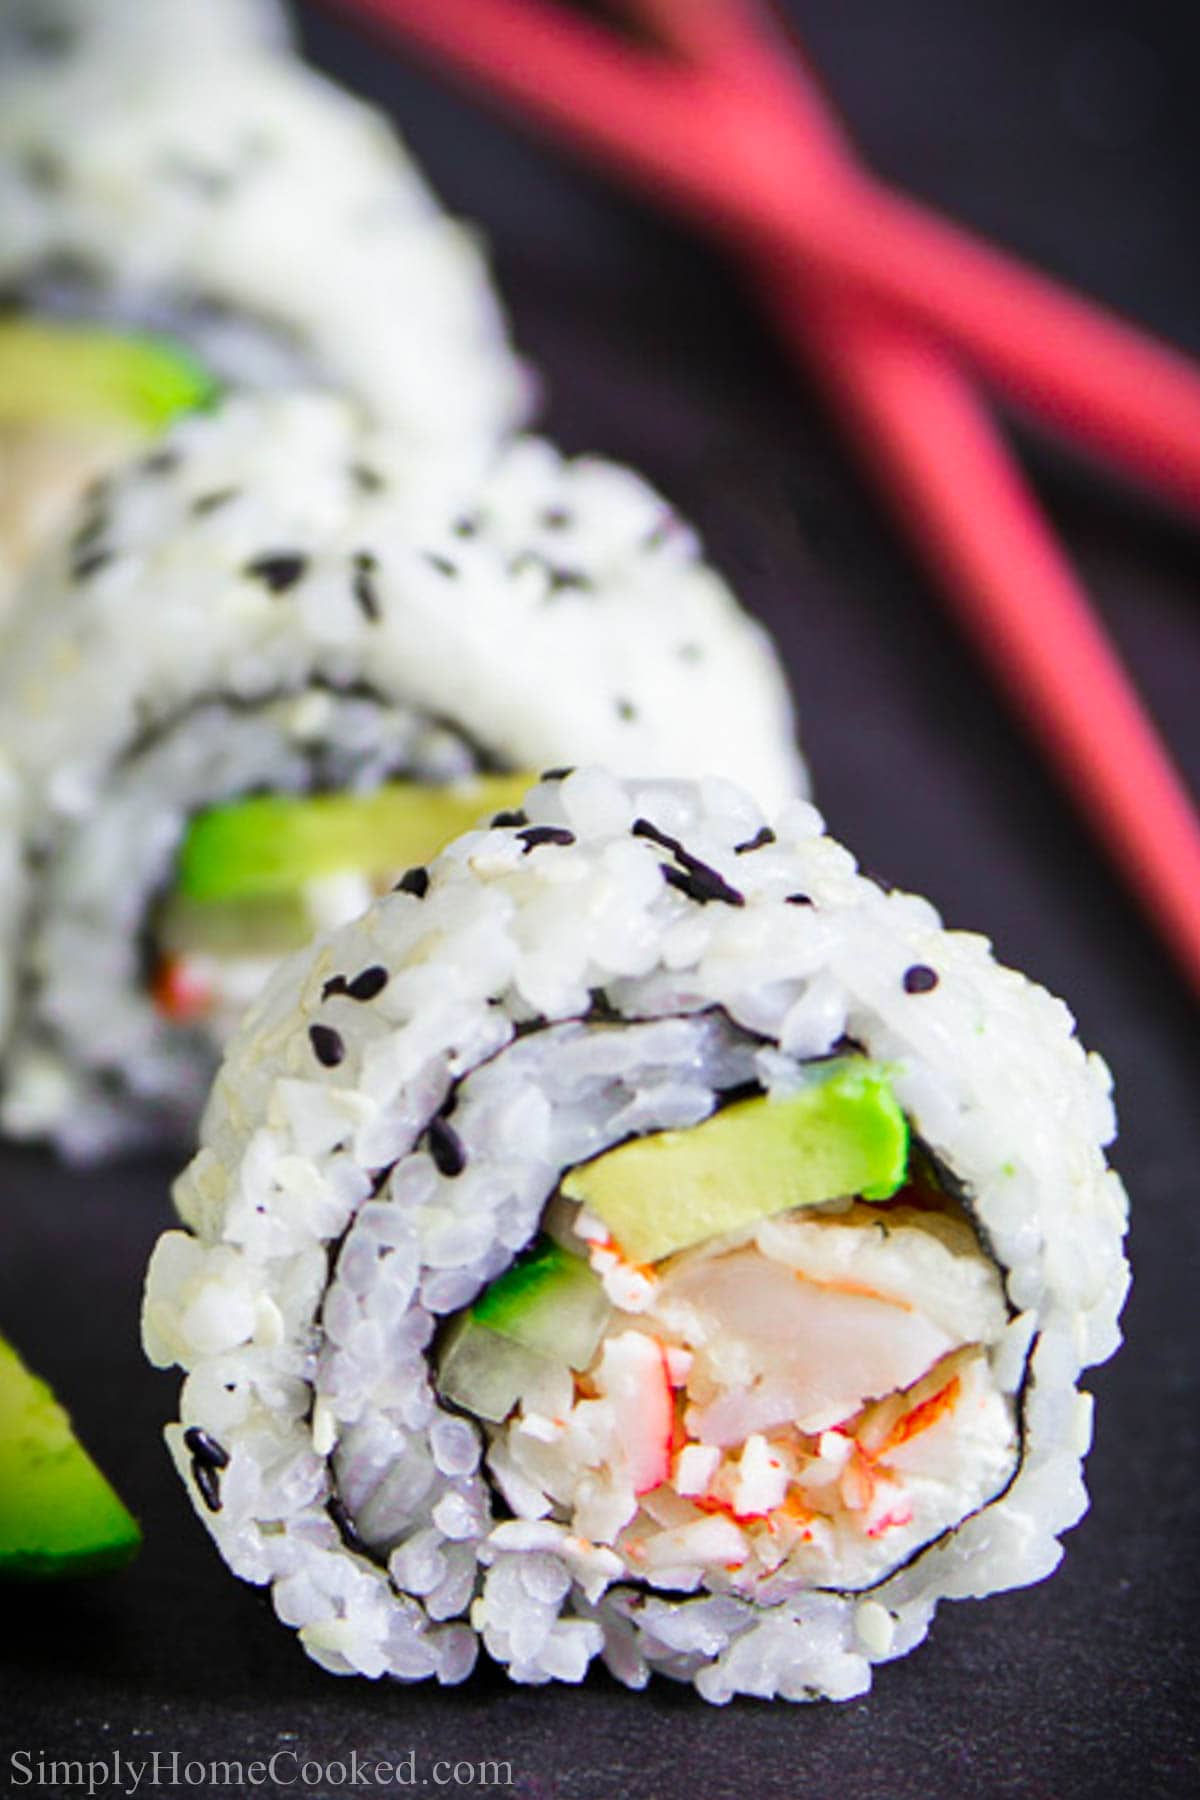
[0,0,1200,1800]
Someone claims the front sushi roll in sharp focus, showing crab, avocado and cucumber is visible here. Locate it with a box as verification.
[144,769,1128,1703]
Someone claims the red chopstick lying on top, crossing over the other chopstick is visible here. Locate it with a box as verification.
[327,0,1200,509]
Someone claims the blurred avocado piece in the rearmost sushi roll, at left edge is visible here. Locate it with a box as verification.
[0,317,216,439]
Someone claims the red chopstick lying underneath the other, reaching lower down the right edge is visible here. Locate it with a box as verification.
[628,0,1200,988]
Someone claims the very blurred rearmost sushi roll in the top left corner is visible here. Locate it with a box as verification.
[0,0,529,605]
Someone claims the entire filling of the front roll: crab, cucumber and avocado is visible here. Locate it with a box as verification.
[439,1058,1018,1597]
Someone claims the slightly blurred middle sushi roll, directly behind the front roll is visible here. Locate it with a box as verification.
[0,392,802,1156]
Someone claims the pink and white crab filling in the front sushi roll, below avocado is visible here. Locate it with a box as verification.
[488,1201,1018,1598]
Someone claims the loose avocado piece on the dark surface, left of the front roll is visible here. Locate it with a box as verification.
[0,1337,142,1579]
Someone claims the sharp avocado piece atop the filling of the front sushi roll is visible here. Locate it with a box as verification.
[561,1057,909,1262]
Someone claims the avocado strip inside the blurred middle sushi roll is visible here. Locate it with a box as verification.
[176,774,536,902]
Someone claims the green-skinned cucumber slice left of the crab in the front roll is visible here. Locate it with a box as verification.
[471,1237,612,1368]
